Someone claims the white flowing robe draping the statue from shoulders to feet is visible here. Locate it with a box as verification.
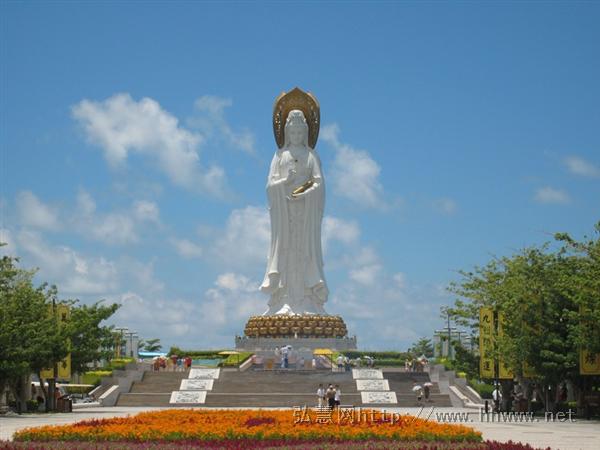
[260,149,328,314]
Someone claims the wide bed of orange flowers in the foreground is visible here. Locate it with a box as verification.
[14,409,481,443]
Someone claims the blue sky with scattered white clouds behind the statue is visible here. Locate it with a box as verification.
[0,1,600,349]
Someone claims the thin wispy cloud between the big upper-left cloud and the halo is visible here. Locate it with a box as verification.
[190,95,256,154]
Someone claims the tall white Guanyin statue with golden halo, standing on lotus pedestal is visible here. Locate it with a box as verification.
[260,89,329,315]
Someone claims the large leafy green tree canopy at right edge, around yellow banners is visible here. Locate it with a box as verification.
[442,226,600,410]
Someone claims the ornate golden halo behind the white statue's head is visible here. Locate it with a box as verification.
[273,87,321,148]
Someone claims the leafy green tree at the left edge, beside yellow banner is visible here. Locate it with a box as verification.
[0,251,118,412]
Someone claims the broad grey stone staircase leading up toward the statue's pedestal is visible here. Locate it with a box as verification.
[117,369,451,408]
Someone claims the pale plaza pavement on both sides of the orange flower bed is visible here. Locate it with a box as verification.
[0,406,600,450]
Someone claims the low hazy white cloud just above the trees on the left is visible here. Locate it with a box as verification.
[17,231,118,295]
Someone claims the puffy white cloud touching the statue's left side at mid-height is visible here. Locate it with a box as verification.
[212,206,271,268]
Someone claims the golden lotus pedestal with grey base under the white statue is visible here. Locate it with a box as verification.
[236,315,356,351]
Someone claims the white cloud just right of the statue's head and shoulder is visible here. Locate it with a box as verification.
[320,124,388,209]
